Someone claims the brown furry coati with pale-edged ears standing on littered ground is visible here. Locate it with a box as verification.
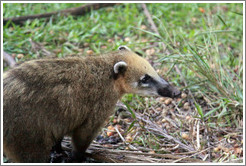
[3,46,180,163]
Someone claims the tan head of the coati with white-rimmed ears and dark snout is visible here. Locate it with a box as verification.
[114,46,180,98]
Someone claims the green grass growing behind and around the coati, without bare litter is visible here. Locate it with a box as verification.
[3,3,243,161]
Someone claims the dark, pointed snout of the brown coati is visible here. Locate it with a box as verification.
[157,79,181,98]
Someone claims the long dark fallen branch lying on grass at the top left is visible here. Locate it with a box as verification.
[3,3,117,24]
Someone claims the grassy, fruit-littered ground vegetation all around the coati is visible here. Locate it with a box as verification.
[3,3,244,162]
